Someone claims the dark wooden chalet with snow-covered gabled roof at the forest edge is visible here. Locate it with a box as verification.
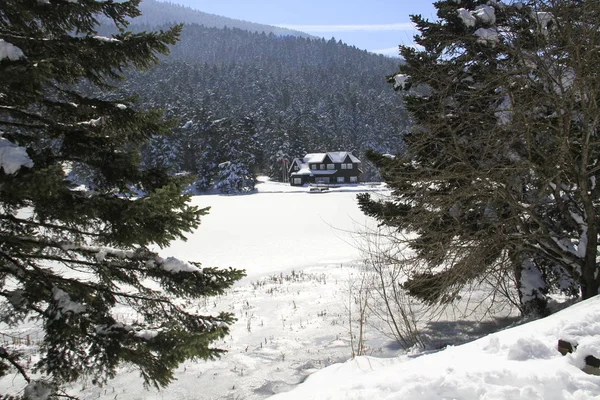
[288,151,362,186]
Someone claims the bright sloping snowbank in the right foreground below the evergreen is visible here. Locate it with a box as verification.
[271,297,600,400]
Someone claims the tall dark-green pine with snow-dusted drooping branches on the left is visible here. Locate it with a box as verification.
[0,0,243,399]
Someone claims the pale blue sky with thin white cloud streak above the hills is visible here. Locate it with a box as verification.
[161,0,435,55]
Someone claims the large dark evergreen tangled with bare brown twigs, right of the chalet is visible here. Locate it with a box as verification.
[360,0,600,312]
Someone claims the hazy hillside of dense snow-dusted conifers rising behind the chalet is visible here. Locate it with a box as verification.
[106,3,408,192]
